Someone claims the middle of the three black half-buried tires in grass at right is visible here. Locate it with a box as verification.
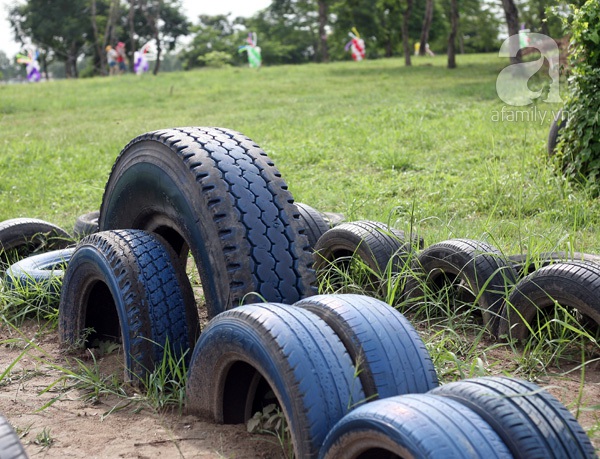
[404,239,517,334]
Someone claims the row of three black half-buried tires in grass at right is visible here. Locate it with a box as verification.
[314,221,600,340]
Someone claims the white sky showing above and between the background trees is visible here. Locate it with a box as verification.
[0,0,271,57]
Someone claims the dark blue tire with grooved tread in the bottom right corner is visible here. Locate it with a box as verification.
[431,376,597,459]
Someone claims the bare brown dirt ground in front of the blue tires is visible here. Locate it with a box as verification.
[0,325,600,459]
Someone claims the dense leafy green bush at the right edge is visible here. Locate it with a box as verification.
[558,0,600,195]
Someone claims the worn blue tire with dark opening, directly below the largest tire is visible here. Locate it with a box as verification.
[186,303,365,458]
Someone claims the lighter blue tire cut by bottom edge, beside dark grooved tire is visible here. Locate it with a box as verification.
[319,394,512,459]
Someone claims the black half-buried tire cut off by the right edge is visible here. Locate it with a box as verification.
[498,262,600,340]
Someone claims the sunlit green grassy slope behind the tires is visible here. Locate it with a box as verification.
[0,55,600,253]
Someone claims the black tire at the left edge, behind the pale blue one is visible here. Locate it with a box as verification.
[0,218,74,270]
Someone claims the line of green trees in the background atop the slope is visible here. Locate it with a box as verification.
[0,0,581,78]
